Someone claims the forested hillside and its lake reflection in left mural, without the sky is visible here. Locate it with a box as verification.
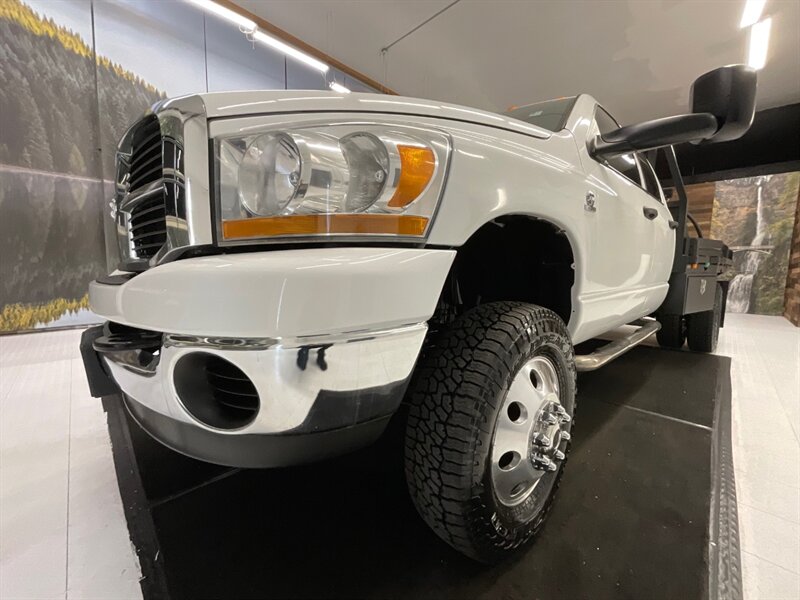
[0,0,164,331]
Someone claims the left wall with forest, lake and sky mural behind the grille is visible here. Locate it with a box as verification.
[0,0,380,332]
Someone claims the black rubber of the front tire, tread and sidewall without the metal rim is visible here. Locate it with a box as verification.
[405,302,576,563]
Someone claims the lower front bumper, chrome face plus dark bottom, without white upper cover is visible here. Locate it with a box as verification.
[87,323,427,467]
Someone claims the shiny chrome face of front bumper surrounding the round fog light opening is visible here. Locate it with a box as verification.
[104,324,427,436]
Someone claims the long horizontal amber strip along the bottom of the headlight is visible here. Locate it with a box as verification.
[222,214,428,240]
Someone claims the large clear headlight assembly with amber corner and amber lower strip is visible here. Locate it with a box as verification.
[215,124,450,243]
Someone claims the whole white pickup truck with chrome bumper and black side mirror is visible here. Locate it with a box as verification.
[81,66,755,562]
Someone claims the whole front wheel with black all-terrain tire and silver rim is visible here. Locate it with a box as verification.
[405,302,576,563]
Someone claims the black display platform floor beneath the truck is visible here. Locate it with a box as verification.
[104,347,741,600]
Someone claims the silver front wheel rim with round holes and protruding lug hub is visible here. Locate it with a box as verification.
[491,356,572,506]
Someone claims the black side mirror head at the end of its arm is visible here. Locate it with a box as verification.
[691,65,758,144]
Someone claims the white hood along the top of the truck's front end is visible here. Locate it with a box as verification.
[159,90,552,139]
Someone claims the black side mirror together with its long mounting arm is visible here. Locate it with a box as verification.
[590,65,756,157]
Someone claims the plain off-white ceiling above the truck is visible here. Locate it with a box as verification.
[237,0,800,123]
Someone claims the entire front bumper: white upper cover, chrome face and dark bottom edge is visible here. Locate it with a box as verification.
[84,248,454,467]
